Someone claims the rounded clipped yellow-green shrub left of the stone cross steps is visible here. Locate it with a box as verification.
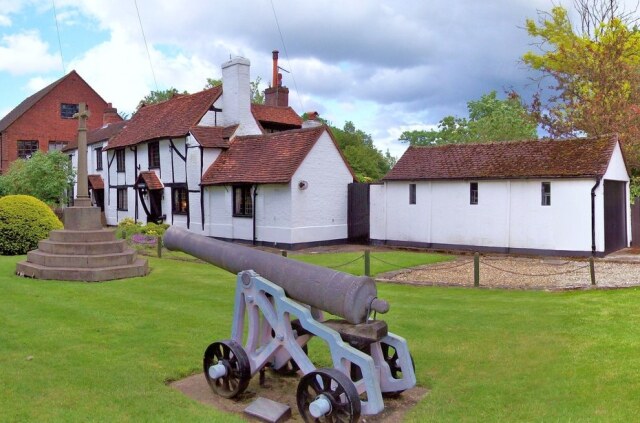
[0,195,63,255]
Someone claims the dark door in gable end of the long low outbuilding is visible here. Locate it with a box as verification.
[604,181,627,254]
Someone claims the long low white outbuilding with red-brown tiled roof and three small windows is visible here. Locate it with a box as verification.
[370,136,631,256]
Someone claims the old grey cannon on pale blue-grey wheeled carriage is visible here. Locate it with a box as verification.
[164,227,416,421]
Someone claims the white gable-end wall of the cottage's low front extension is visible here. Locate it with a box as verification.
[290,131,353,243]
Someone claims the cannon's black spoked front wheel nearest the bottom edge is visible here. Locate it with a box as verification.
[296,369,360,422]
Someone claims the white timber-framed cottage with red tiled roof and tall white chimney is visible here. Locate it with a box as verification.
[70,55,354,248]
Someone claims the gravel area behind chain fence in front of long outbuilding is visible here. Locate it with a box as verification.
[377,256,640,290]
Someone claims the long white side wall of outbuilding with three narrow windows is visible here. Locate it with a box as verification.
[371,179,604,255]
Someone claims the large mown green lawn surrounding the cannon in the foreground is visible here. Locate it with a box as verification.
[0,255,640,422]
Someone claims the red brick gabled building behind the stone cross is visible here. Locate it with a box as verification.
[0,71,122,173]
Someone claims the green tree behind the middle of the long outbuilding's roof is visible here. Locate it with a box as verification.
[400,91,537,146]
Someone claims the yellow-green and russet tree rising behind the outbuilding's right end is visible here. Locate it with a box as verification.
[523,0,640,169]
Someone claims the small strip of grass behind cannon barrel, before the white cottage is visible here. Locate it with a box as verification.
[289,250,453,276]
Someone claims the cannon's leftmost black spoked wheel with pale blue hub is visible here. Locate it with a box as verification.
[203,340,251,398]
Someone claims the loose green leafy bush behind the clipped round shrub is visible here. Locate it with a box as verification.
[0,151,75,205]
